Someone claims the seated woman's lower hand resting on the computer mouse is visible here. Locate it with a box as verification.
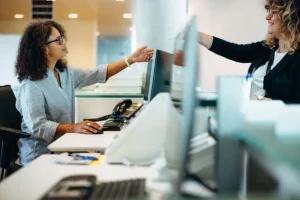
[67,121,102,134]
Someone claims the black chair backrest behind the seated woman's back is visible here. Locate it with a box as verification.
[0,85,22,130]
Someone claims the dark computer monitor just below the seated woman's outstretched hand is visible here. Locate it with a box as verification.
[144,49,173,101]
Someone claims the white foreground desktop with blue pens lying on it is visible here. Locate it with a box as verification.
[0,155,211,200]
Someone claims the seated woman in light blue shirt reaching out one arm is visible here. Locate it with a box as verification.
[16,21,153,165]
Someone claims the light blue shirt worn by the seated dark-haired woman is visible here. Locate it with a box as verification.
[16,65,107,165]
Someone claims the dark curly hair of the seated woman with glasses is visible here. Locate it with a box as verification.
[15,21,67,82]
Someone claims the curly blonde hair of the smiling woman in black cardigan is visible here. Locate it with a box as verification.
[265,0,300,53]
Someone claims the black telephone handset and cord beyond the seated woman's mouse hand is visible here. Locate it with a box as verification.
[83,99,132,122]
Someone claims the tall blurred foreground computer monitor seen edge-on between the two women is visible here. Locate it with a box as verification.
[175,17,199,193]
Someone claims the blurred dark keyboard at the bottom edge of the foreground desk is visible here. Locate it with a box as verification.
[89,179,146,200]
